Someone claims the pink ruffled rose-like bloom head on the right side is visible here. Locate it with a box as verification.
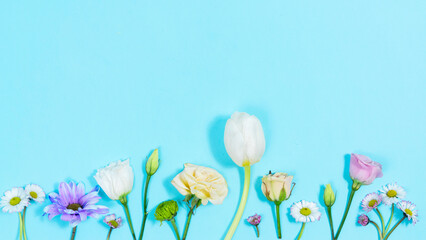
[349,153,383,185]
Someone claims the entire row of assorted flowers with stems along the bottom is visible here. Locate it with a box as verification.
[0,112,418,240]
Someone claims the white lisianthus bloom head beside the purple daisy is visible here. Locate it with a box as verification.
[95,159,134,200]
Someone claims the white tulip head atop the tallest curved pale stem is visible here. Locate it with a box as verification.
[224,112,265,167]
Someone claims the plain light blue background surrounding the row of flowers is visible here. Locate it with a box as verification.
[0,0,426,240]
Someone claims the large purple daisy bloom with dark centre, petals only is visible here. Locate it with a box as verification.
[44,182,108,227]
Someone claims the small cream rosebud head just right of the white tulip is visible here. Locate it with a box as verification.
[262,172,293,202]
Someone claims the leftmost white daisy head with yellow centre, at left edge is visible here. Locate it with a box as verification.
[0,188,29,213]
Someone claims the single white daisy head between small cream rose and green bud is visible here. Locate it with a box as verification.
[290,200,321,222]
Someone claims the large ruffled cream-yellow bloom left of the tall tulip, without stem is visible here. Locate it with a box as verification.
[172,163,228,205]
